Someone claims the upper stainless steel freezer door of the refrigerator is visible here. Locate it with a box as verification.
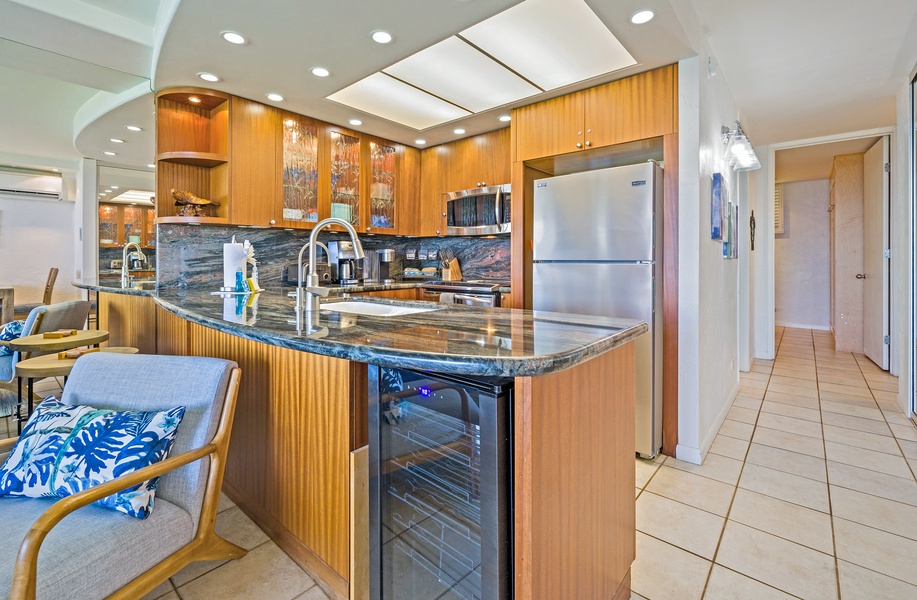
[532,163,662,261]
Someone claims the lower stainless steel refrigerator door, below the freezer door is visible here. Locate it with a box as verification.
[532,263,662,458]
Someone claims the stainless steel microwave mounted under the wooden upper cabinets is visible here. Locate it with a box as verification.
[443,183,512,235]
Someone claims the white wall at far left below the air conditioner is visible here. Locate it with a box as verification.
[0,198,79,304]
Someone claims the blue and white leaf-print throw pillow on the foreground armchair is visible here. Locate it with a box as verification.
[0,396,185,519]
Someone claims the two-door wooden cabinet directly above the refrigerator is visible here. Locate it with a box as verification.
[513,65,677,161]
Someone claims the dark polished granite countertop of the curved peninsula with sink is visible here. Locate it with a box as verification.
[74,280,647,377]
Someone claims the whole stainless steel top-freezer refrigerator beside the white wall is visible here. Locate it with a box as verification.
[532,162,663,457]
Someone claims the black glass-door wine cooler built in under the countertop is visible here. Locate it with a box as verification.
[369,365,513,600]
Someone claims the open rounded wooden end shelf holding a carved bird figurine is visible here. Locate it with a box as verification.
[156,88,230,223]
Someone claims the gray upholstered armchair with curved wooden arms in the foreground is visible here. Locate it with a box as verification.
[0,353,245,600]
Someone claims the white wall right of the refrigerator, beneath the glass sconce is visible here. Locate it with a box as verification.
[676,51,747,463]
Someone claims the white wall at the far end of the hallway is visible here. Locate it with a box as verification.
[774,179,831,330]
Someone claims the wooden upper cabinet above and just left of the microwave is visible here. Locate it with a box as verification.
[414,128,511,236]
